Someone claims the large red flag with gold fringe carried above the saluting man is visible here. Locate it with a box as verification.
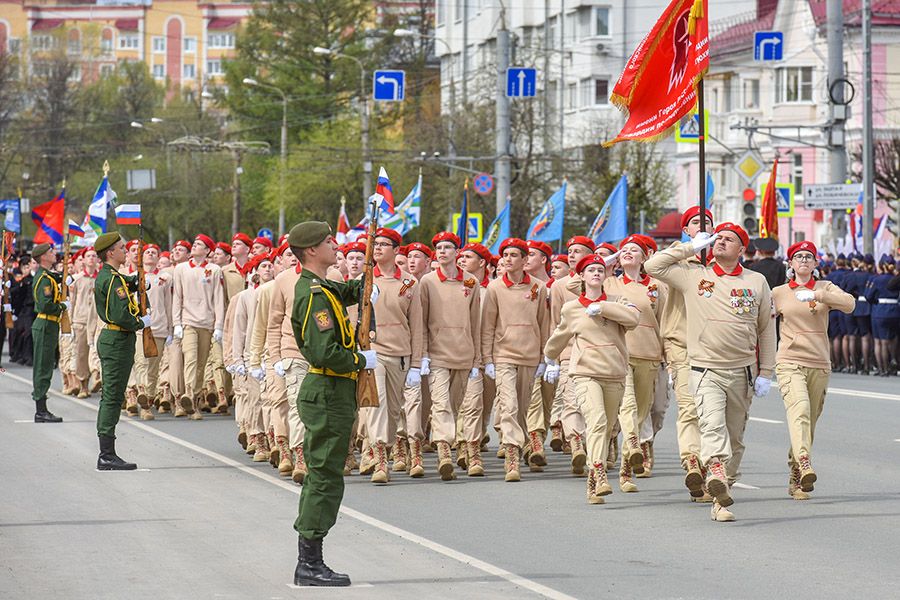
[603,0,709,146]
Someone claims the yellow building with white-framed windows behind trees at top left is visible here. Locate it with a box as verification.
[0,0,251,90]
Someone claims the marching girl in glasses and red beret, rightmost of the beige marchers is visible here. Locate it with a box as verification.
[772,241,856,500]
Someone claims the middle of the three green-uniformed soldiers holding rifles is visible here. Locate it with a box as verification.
[94,231,150,471]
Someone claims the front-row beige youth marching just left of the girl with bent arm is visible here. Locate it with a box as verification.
[481,238,550,481]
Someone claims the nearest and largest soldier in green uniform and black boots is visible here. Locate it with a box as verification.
[288,221,377,586]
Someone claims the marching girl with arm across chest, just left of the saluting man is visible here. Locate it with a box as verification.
[544,254,640,504]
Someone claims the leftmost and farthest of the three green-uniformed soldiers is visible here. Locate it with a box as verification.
[31,244,71,423]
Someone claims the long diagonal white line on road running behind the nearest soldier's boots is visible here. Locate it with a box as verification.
[2,371,576,600]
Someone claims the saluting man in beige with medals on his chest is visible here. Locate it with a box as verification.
[644,223,775,521]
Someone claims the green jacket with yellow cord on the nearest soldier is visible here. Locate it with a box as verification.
[291,270,366,374]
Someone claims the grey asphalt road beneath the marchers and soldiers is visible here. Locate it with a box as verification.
[0,366,900,600]
